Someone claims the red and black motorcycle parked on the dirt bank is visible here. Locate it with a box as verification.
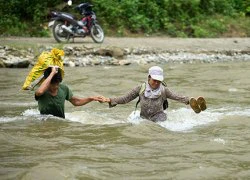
[49,1,104,43]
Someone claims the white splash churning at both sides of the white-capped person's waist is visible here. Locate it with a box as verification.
[128,107,250,132]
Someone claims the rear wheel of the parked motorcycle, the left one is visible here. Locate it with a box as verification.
[52,21,70,43]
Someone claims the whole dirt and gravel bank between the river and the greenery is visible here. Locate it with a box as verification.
[0,37,250,67]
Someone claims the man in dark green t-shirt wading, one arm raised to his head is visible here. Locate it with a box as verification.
[35,66,103,118]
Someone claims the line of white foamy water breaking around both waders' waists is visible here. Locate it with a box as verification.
[0,107,250,132]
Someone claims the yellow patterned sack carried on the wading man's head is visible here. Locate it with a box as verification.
[22,48,64,90]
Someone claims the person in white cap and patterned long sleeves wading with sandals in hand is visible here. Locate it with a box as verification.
[104,66,206,122]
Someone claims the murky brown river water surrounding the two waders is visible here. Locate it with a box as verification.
[0,62,250,179]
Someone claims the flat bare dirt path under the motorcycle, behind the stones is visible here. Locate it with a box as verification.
[0,37,250,52]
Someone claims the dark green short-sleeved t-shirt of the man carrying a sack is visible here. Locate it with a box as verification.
[35,84,73,118]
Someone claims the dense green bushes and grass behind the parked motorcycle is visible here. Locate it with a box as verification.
[0,0,250,38]
